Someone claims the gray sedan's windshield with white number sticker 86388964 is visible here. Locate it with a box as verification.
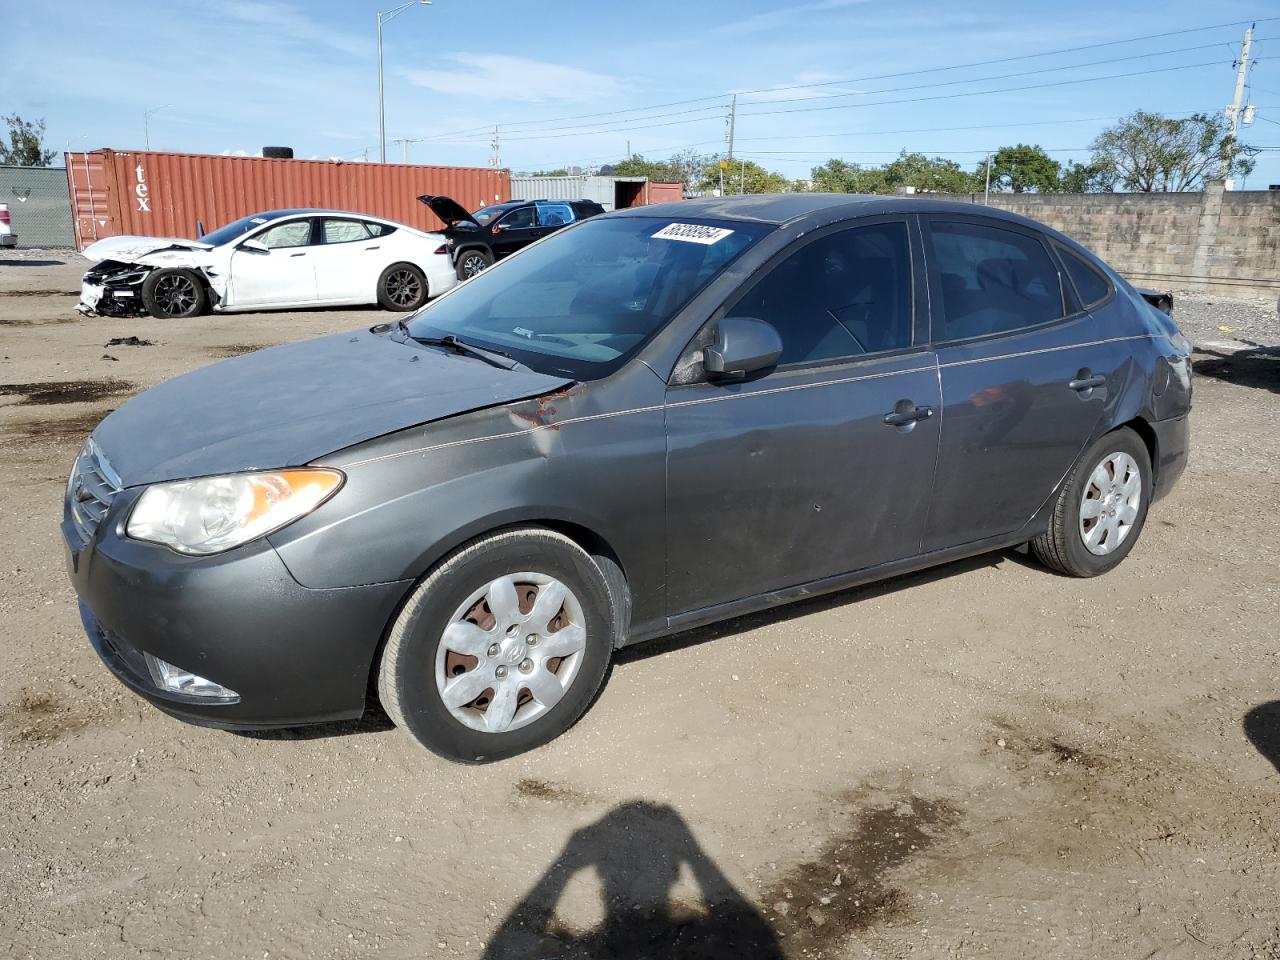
[408,216,773,380]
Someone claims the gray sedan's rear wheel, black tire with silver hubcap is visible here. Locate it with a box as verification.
[1030,428,1152,577]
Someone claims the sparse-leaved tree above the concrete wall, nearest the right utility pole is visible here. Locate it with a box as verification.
[1089,110,1258,193]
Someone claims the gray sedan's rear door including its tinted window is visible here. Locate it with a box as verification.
[920,215,1116,550]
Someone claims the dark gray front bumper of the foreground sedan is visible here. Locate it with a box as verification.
[63,499,408,728]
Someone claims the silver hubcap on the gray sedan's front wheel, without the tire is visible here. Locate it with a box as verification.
[435,572,586,733]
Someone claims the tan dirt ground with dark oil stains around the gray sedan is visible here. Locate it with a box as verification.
[0,255,1280,960]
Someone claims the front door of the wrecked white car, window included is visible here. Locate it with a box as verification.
[227,218,316,307]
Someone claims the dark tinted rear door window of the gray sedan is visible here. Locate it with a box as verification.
[929,223,1066,340]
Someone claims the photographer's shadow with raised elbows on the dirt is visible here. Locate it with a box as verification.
[484,801,782,960]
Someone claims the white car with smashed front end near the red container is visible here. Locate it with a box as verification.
[78,210,458,319]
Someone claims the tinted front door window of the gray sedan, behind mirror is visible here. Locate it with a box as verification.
[730,223,911,364]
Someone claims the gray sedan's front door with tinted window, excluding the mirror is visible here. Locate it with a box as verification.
[667,219,941,616]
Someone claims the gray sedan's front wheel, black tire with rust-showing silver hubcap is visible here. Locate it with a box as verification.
[378,527,621,763]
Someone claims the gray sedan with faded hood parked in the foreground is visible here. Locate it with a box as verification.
[63,195,1192,760]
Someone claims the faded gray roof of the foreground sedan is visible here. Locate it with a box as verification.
[604,193,1047,232]
